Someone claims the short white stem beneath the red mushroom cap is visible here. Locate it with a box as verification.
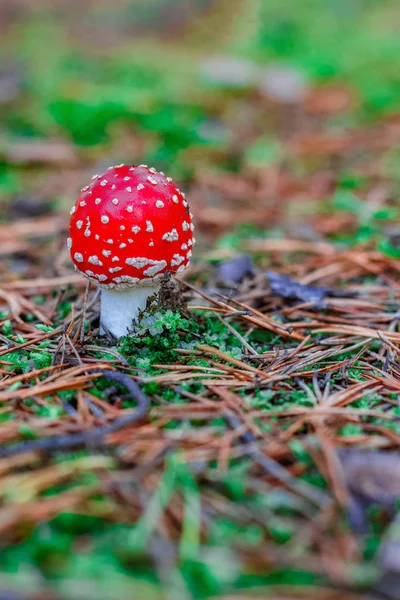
[100,284,160,338]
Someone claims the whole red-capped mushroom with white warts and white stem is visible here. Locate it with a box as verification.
[68,165,194,338]
